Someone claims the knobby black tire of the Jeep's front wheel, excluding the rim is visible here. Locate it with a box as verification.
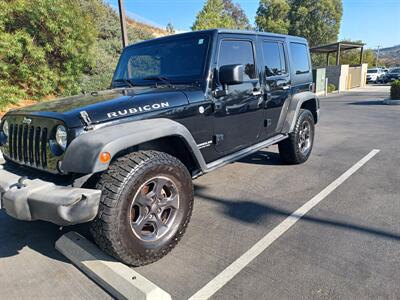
[90,151,193,266]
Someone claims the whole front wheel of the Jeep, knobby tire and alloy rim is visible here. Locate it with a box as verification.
[91,151,193,266]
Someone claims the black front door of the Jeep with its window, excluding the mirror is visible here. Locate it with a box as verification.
[214,37,264,153]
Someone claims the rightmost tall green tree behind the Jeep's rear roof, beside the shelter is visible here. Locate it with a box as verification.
[289,0,343,46]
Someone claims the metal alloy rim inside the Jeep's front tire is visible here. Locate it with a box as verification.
[129,176,179,242]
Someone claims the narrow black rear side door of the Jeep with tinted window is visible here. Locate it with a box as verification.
[261,39,291,137]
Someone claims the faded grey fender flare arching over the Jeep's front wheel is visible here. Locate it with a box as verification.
[61,118,206,174]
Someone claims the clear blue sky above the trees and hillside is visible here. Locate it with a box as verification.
[105,0,400,49]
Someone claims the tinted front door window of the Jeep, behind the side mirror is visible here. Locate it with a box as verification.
[218,40,257,81]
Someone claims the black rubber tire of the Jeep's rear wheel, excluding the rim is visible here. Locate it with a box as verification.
[278,109,314,164]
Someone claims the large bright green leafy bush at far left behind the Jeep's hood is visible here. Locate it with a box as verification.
[0,0,97,106]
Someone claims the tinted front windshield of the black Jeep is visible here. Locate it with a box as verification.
[113,35,209,87]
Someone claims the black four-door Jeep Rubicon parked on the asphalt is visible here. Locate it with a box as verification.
[0,30,319,266]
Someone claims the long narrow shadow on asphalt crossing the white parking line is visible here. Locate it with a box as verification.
[195,185,400,241]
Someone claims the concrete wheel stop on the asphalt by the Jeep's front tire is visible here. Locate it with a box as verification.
[56,232,171,300]
